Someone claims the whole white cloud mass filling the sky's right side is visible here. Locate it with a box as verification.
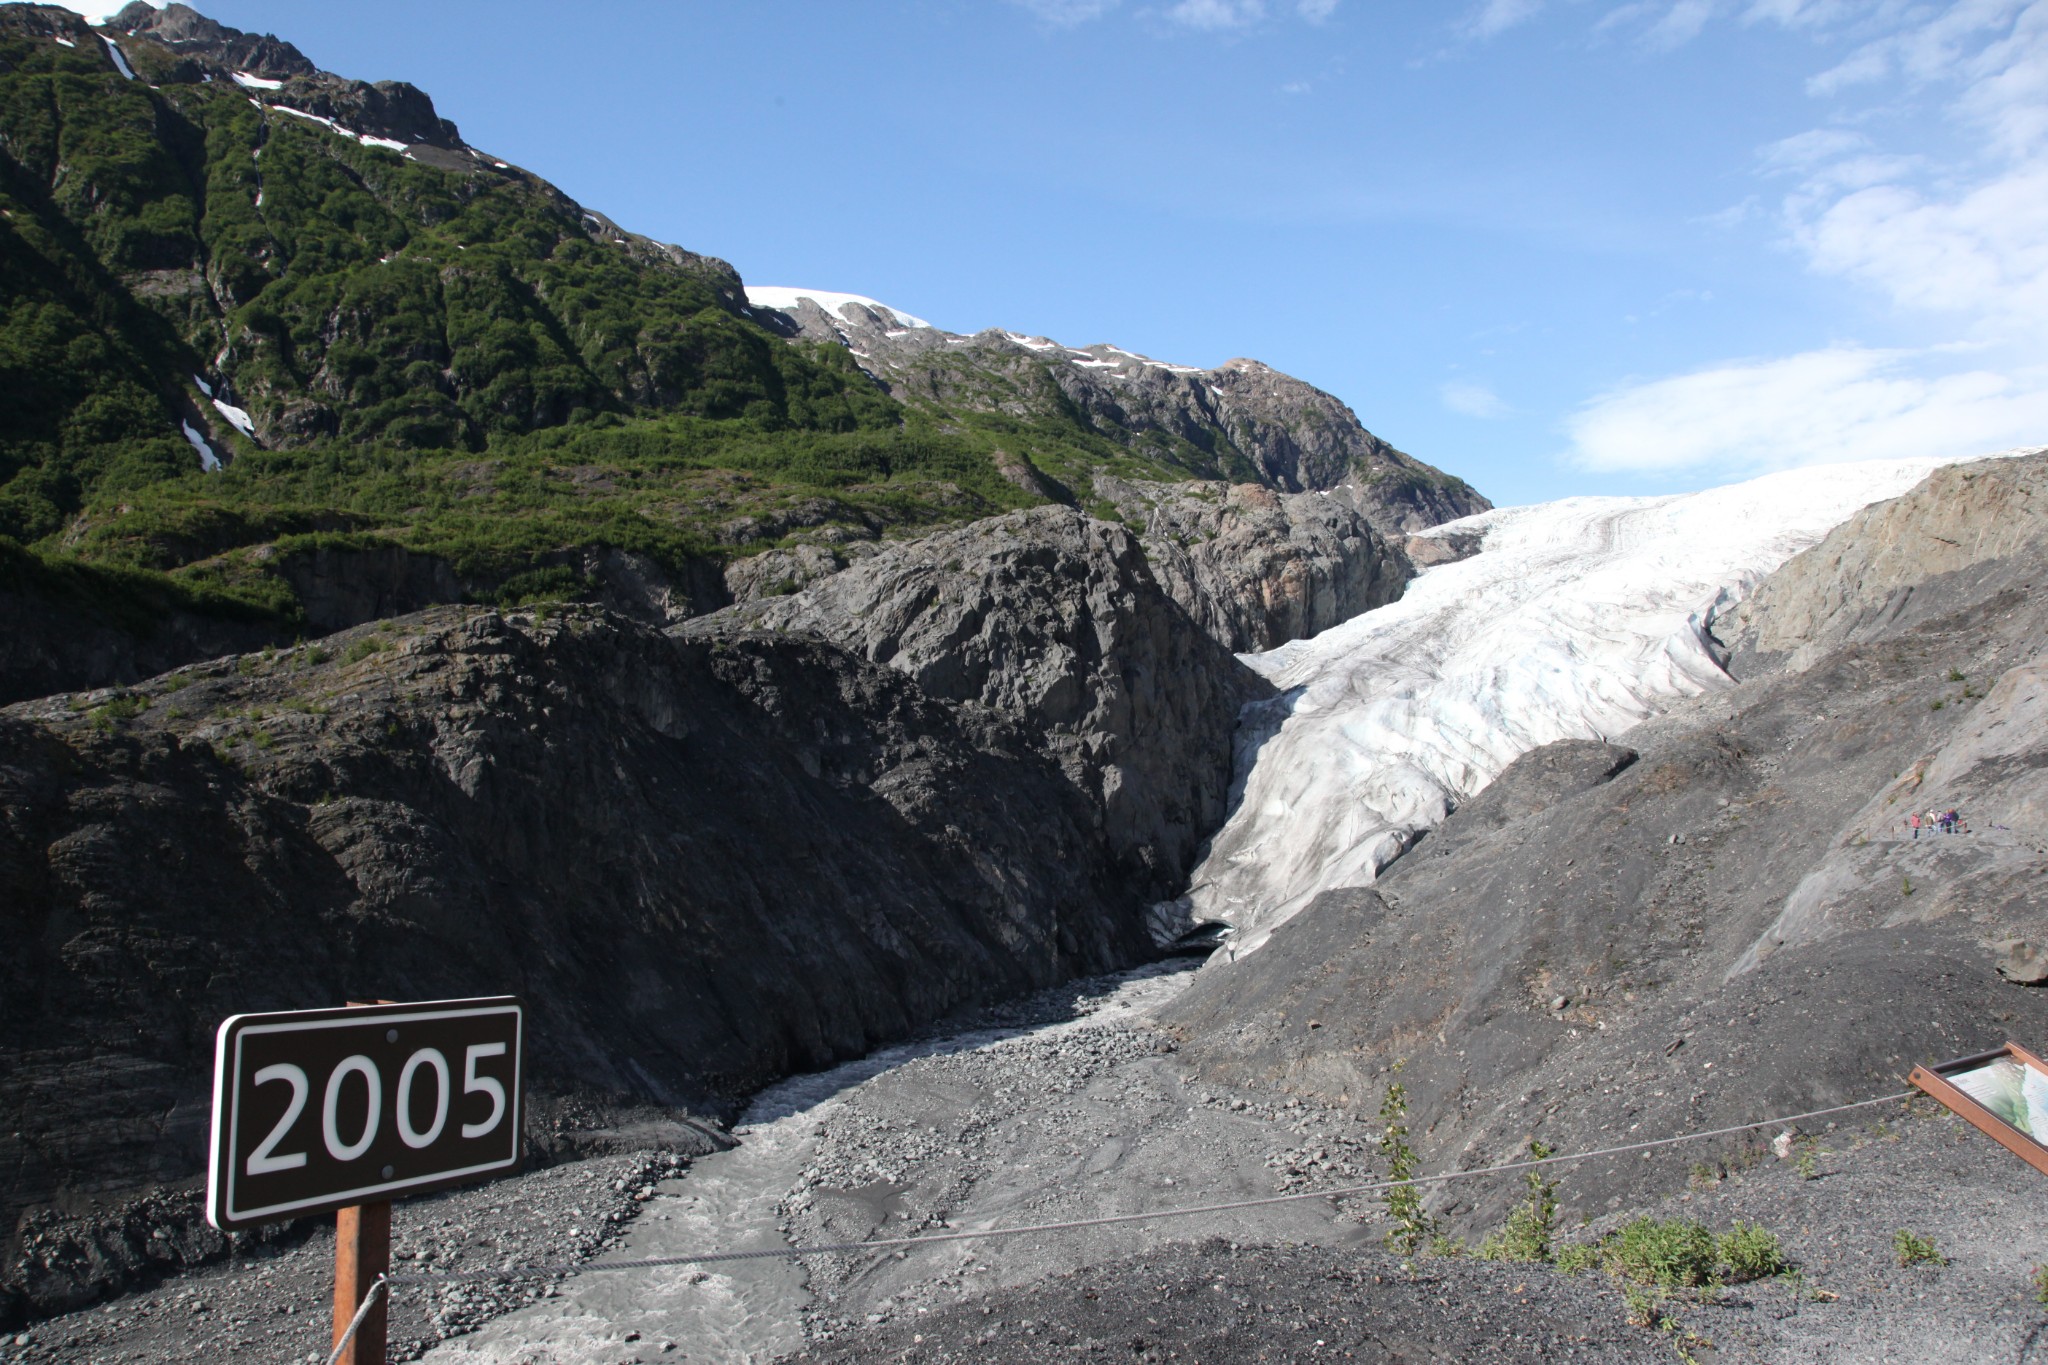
[1567,0,2048,479]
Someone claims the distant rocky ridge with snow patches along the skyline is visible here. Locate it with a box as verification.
[754,297,1493,536]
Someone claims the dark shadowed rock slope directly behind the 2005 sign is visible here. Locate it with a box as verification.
[0,609,1155,1312]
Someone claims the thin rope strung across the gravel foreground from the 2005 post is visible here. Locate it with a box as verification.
[376,1091,1917,1293]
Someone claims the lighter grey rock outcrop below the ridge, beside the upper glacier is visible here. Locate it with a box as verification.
[1096,475,1413,653]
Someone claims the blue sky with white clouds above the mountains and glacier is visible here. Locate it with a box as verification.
[64,0,2048,503]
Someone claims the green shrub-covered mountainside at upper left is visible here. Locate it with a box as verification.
[0,6,1228,620]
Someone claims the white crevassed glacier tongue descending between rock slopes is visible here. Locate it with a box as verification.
[1188,460,1974,956]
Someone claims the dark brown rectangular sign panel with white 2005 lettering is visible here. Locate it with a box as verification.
[207,997,526,1230]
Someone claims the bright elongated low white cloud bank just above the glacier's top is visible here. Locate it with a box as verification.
[1567,346,2048,479]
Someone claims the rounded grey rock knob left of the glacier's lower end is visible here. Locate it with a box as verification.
[712,508,1262,898]
